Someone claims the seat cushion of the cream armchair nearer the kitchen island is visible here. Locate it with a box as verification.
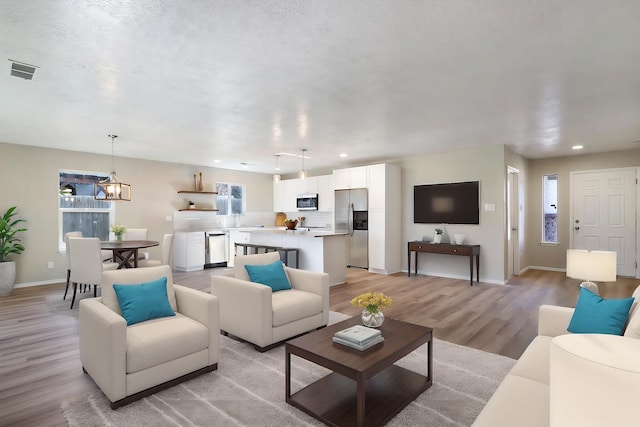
[271,289,323,327]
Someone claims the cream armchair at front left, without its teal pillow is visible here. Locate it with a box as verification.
[80,265,220,409]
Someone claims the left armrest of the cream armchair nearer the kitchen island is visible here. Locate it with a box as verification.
[211,276,273,346]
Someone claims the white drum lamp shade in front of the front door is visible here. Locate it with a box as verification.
[567,249,618,282]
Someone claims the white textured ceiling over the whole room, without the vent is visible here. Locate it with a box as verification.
[0,0,640,173]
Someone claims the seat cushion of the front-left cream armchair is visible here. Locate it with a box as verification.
[127,313,209,374]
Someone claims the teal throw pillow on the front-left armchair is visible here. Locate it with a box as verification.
[113,277,176,326]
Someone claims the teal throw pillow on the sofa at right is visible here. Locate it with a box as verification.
[567,288,634,335]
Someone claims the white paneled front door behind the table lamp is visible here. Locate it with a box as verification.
[571,169,636,276]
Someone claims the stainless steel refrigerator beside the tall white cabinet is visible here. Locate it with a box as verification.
[334,188,369,269]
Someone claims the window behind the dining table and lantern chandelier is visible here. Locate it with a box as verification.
[58,171,114,250]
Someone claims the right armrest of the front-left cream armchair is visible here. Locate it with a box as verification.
[173,284,220,365]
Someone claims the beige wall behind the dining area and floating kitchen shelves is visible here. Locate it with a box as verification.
[0,143,273,284]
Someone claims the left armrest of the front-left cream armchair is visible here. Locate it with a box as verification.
[79,298,127,402]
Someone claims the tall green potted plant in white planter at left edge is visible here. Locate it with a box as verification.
[0,206,27,295]
